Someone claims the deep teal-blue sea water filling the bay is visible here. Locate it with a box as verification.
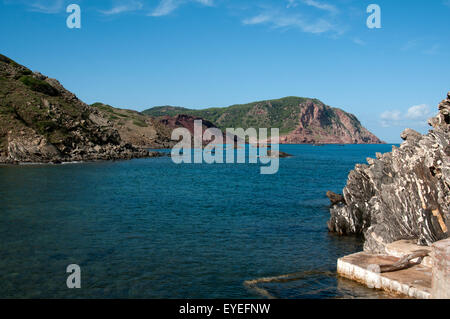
[0,145,400,298]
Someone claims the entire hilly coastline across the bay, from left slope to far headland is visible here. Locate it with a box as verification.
[0,54,383,164]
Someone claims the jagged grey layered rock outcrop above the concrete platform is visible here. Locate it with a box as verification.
[328,93,450,253]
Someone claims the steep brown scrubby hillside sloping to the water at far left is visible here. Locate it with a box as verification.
[0,55,155,163]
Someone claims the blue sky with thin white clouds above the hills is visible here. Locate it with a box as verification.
[0,0,450,143]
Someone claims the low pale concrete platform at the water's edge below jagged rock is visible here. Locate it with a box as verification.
[337,252,432,299]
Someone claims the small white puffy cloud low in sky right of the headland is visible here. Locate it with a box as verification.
[380,104,432,127]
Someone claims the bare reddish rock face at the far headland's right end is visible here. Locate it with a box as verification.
[280,102,384,144]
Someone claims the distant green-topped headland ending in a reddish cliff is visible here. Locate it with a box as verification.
[144,97,383,144]
